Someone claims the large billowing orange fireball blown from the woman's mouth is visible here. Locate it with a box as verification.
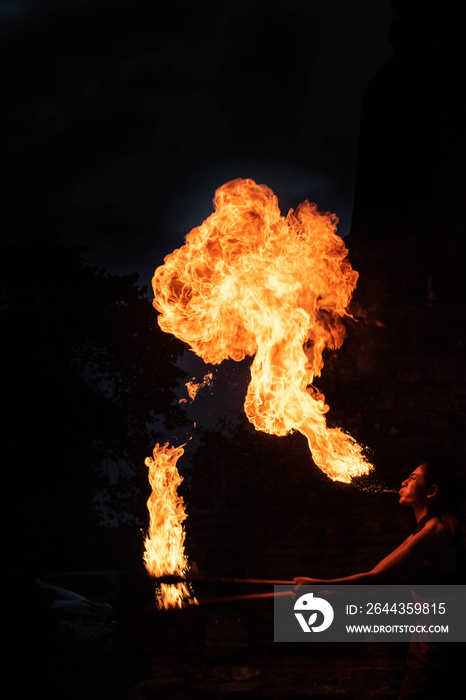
[152,179,372,482]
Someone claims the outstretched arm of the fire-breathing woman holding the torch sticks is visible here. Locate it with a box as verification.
[294,520,445,586]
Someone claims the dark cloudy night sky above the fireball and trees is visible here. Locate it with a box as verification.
[0,0,393,286]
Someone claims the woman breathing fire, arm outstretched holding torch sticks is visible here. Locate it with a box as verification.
[294,462,466,700]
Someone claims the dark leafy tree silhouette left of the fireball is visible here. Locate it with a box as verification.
[0,234,185,562]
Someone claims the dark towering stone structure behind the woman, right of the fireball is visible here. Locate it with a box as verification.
[338,0,466,478]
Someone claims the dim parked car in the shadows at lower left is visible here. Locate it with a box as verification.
[36,579,116,641]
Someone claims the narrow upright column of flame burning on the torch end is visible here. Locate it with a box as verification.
[144,444,197,609]
